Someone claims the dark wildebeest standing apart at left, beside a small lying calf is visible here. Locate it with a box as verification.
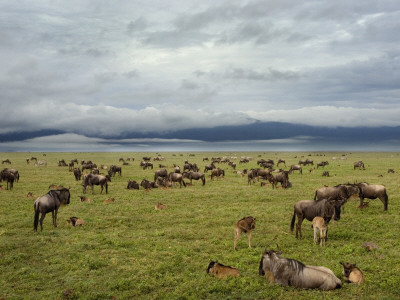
[33,188,71,231]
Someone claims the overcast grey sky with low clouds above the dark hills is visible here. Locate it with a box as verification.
[0,0,400,145]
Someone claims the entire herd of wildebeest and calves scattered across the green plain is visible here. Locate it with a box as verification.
[0,154,394,290]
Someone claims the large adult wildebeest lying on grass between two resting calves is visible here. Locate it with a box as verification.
[258,249,342,291]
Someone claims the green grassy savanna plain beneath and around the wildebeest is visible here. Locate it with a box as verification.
[0,152,400,299]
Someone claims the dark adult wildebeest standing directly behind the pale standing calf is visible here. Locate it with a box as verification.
[290,199,343,238]
